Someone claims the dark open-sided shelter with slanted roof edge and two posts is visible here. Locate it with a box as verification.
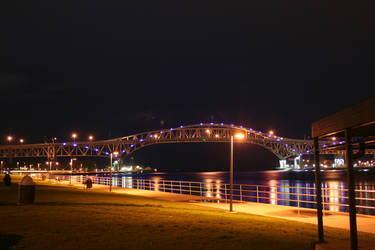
[312,96,375,250]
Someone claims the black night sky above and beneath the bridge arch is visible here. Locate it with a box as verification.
[0,0,375,171]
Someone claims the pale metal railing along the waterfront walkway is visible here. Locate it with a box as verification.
[31,174,375,215]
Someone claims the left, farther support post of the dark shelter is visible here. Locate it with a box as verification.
[314,137,324,242]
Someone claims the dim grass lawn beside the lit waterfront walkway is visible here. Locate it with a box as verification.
[0,177,375,249]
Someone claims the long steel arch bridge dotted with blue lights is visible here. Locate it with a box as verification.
[0,123,324,160]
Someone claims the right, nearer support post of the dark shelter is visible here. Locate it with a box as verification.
[345,128,358,250]
